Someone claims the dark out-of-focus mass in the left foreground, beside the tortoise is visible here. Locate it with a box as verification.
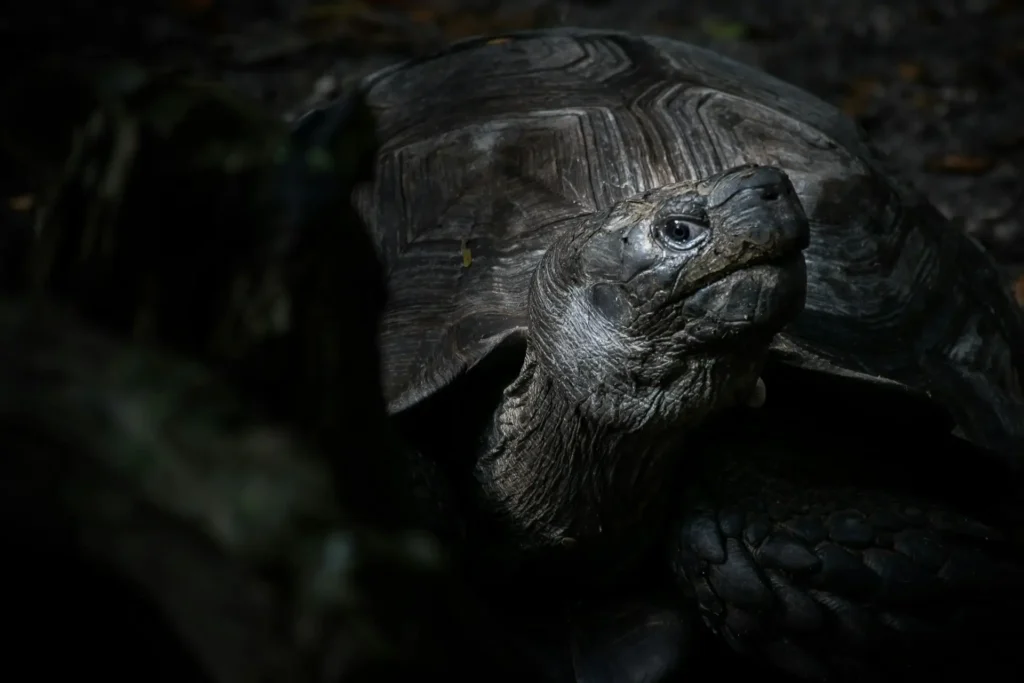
[0,54,538,683]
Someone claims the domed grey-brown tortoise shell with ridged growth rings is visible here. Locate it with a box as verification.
[344,29,1024,453]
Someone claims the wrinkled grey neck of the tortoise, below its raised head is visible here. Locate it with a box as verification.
[474,347,678,555]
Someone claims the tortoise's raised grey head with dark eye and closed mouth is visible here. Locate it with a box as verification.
[529,166,809,430]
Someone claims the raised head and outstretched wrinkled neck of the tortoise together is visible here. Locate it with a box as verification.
[474,167,809,556]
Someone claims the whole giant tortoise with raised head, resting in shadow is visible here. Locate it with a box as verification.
[300,29,1024,681]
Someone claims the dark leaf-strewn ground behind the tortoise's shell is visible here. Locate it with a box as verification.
[9,0,1024,304]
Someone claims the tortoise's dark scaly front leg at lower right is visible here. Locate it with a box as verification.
[673,483,1024,682]
